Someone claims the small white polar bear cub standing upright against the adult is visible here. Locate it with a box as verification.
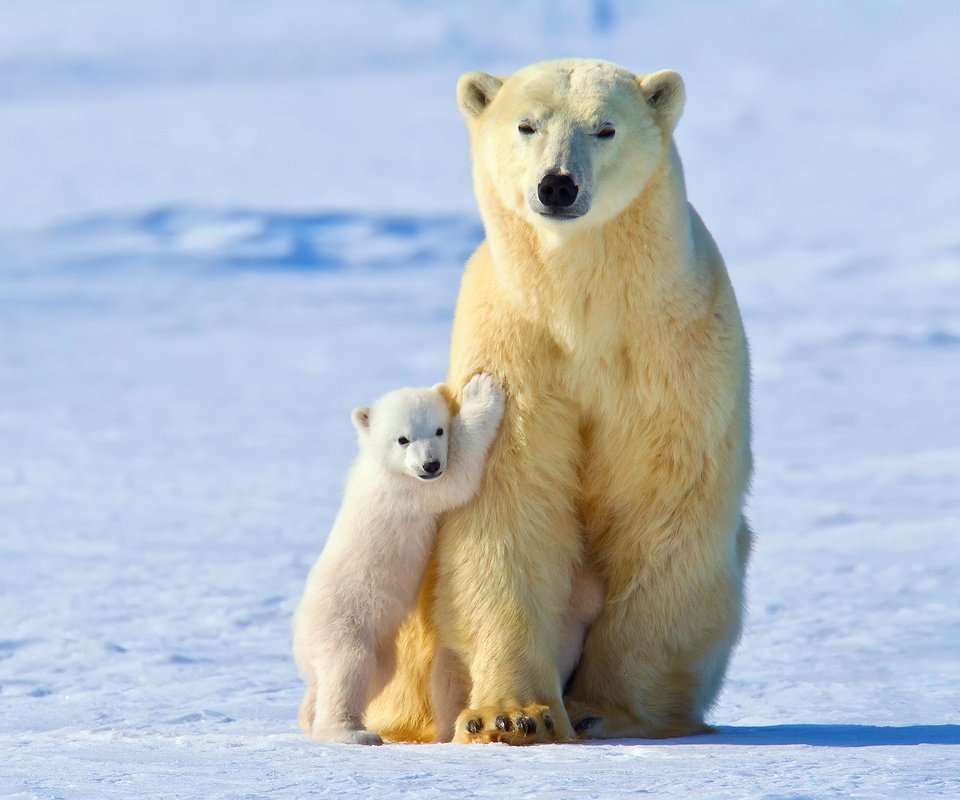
[294,375,504,744]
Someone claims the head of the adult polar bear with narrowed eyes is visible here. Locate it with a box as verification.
[457,59,684,233]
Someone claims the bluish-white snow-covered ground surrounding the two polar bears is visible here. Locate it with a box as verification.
[0,0,960,800]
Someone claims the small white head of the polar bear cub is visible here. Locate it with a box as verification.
[352,384,453,481]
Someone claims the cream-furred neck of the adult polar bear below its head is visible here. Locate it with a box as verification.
[483,145,709,345]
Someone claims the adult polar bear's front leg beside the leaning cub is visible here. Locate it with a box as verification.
[434,390,581,744]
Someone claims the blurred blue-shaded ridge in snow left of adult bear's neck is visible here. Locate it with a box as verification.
[42,206,483,272]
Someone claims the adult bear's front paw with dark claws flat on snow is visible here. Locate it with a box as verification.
[453,705,574,745]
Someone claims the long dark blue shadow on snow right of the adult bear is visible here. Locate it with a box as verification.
[589,725,960,747]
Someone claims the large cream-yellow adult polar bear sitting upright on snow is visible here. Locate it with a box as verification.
[368,60,751,743]
